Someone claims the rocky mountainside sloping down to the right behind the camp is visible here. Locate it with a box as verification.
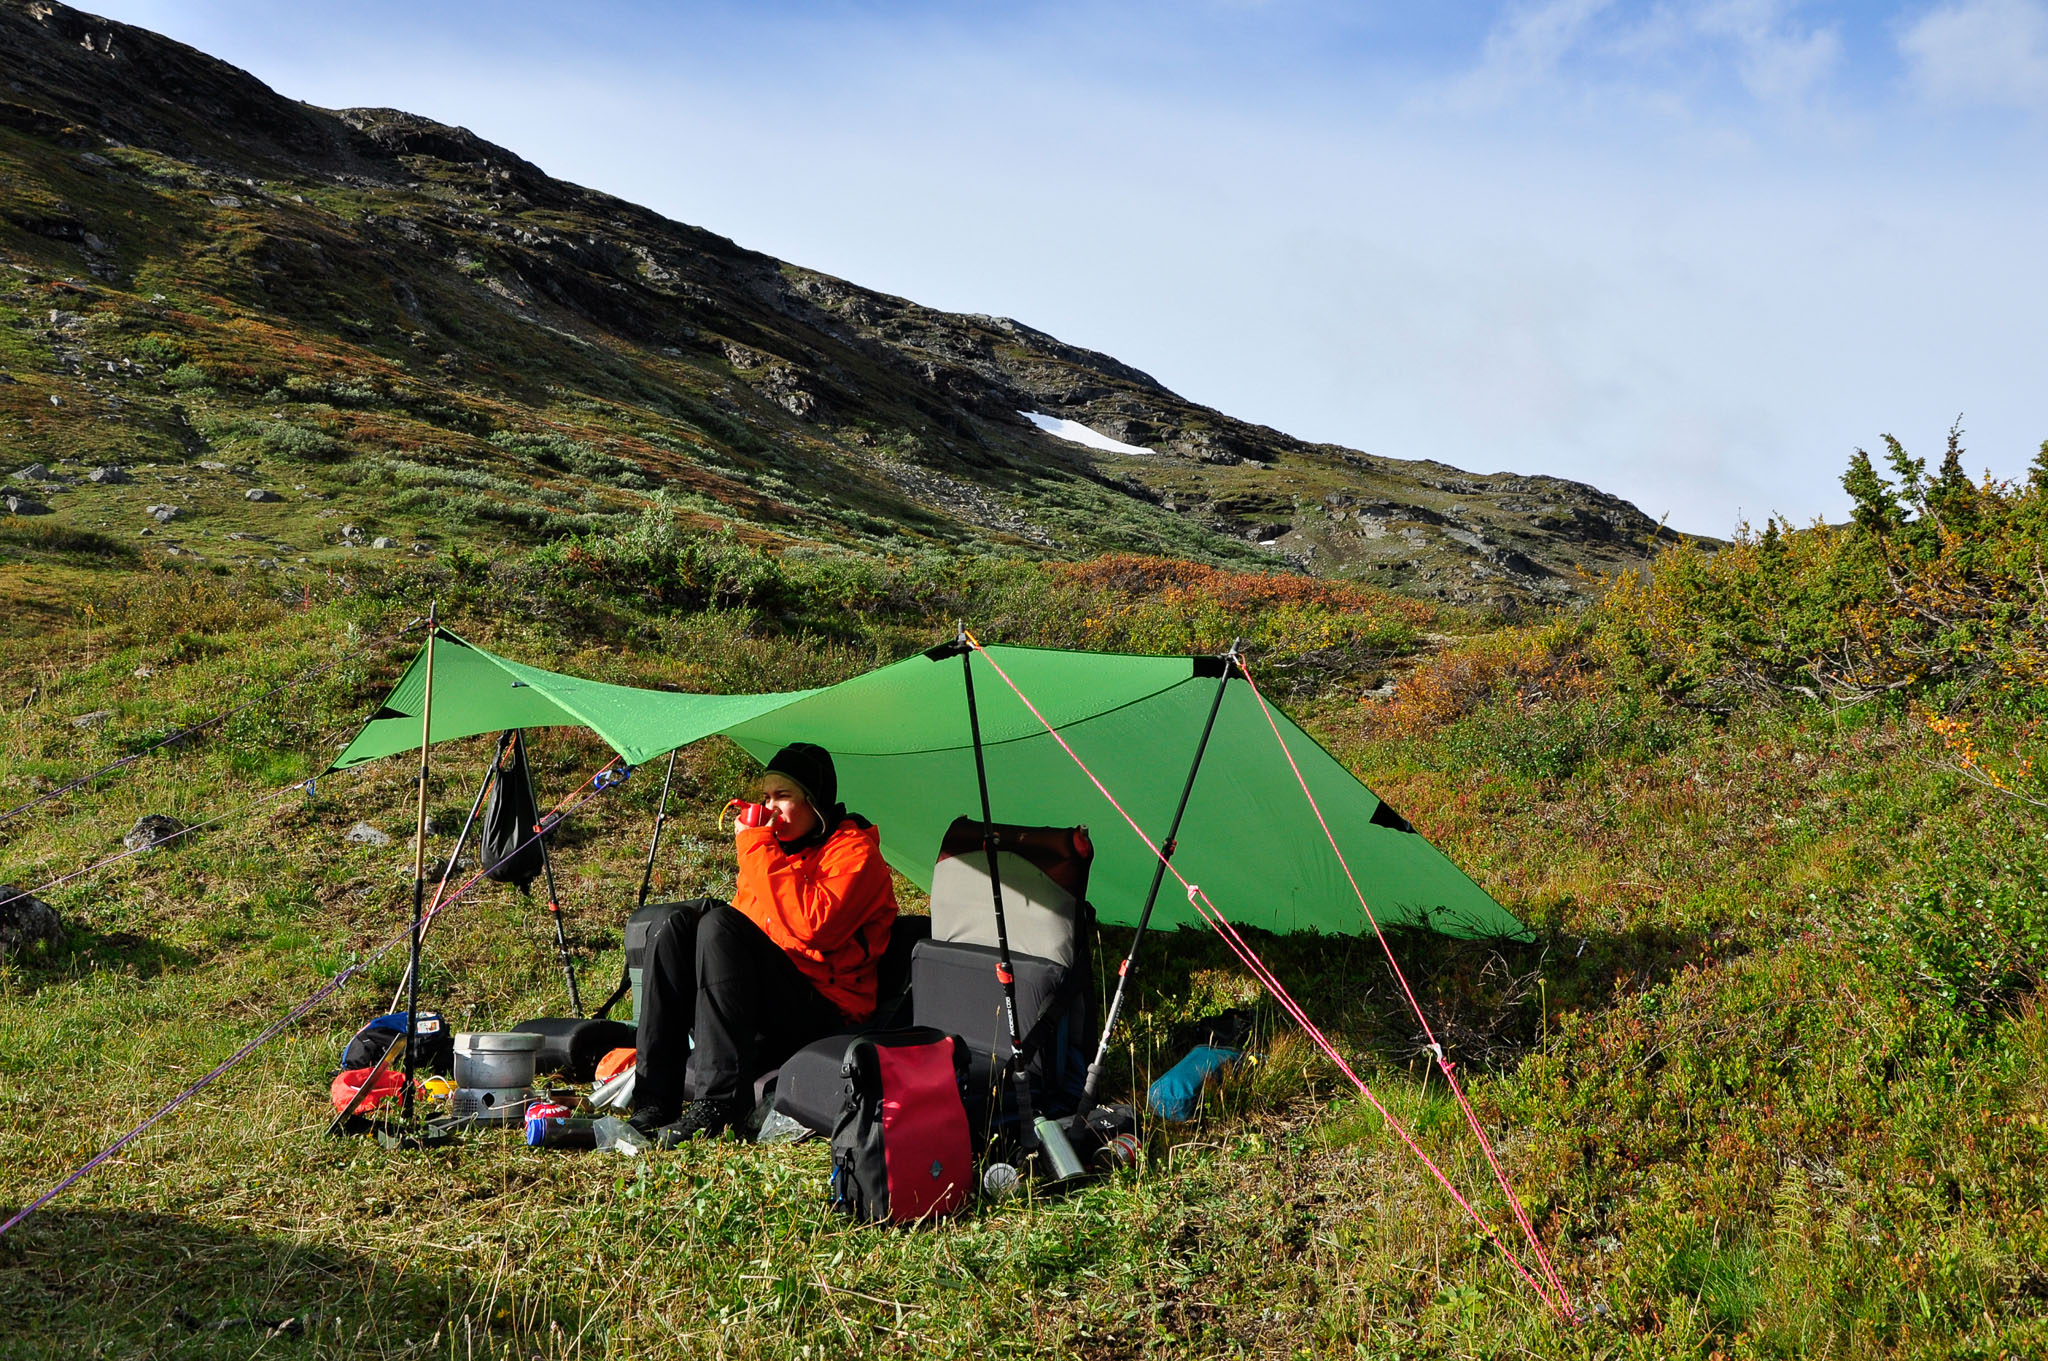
[0,0,1669,604]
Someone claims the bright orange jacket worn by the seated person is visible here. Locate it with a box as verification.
[733,819,897,1021]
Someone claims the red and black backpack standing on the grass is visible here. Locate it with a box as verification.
[831,1025,975,1224]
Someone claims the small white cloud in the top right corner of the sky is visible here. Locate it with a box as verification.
[1898,0,2048,113]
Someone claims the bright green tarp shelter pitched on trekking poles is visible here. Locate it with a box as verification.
[336,630,1524,937]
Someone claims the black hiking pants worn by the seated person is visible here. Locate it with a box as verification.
[633,898,850,1113]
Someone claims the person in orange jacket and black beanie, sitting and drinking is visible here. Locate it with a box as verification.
[633,743,897,1146]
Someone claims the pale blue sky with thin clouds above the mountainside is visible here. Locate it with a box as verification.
[86,0,2048,536]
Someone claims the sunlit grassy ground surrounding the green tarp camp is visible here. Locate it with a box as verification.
[0,536,2048,1357]
